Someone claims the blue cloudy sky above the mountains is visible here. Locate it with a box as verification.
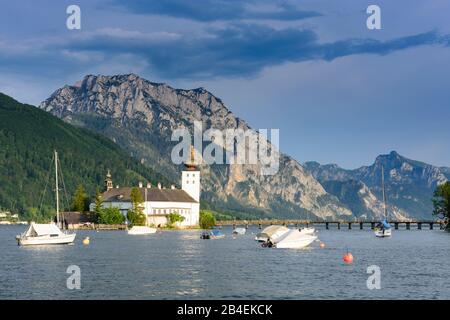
[0,0,450,168]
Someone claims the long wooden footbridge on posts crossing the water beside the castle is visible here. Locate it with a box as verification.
[216,220,445,230]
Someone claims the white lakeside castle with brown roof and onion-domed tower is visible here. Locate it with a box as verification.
[90,152,200,227]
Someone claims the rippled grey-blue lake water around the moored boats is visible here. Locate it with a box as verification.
[0,222,450,299]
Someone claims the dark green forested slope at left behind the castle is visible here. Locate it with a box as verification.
[0,93,170,220]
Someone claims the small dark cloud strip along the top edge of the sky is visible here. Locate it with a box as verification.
[111,0,320,22]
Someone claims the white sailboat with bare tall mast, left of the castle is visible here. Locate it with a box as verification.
[16,151,76,246]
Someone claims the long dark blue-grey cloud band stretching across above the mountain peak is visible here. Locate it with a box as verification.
[0,23,449,79]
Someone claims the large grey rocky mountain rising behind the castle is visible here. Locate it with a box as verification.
[40,74,352,218]
